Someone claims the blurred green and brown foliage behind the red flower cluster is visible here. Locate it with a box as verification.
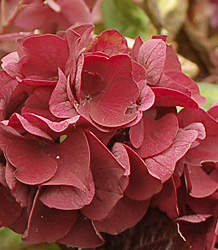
[0,0,218,250]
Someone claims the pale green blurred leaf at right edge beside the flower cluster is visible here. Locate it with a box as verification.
[198,82,218,110]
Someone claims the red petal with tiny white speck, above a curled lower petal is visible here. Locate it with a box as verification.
[44,129,91,192]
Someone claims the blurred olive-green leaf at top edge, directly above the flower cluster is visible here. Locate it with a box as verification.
[101,0,150,39]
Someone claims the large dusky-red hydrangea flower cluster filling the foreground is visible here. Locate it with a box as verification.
[0,23,218,249]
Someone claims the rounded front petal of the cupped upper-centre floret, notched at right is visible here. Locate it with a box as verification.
[90,78,139,127]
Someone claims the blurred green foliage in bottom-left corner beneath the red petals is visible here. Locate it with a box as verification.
[0,227,60,250]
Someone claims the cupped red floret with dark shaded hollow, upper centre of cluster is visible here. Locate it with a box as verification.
[78,55,139,127]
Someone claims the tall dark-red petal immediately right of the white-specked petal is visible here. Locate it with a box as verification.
[82,132,124,220]
